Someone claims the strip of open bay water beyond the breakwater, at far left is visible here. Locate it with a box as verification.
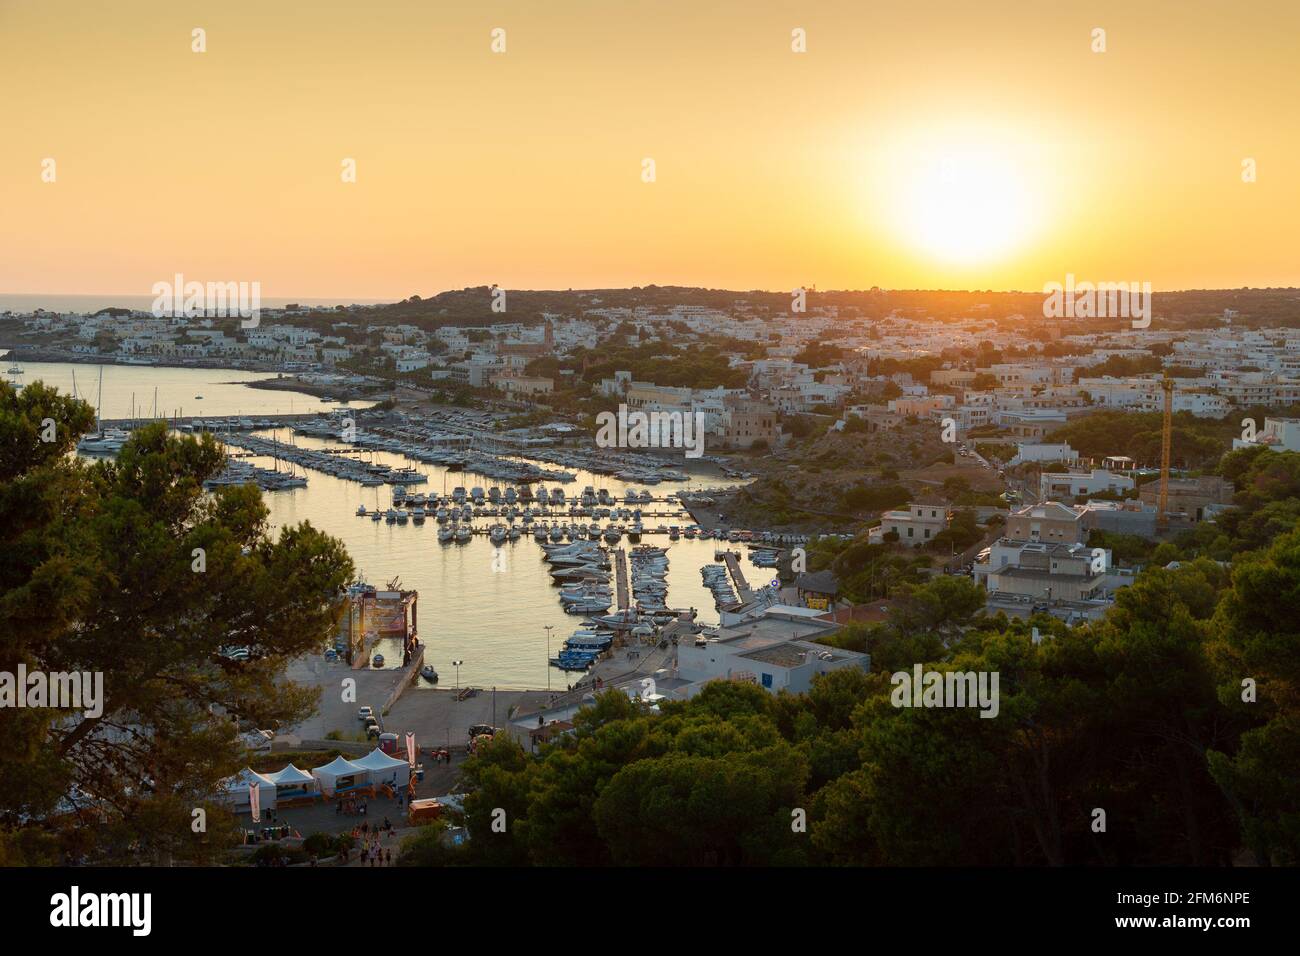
[0,359,371,419]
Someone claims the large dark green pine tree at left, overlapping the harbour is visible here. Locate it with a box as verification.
[0,382,352,861]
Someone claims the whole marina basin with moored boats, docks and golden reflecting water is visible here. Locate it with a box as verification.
[23,363,800,693]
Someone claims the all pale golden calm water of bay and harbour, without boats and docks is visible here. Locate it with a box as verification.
[20,363,771,688]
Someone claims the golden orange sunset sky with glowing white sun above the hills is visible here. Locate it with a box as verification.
[0,0,1300,299]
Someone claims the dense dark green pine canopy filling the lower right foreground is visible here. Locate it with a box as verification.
[421,533,1300,866]
